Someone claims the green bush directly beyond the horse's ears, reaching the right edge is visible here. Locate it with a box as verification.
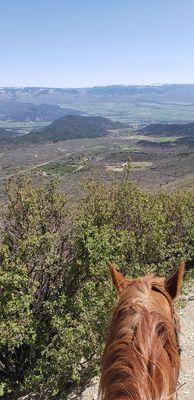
[79,179,194,277]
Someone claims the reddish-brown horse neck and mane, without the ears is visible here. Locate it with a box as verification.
[100,282,179,400]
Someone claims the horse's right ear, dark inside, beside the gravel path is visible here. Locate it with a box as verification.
[165,262,185,300]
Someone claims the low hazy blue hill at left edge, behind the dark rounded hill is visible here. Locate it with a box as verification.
[0,101,80,122]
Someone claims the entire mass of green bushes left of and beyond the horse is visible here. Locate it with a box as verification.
[0,178,194,397]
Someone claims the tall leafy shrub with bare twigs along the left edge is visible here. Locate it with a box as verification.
[0,178,75,392]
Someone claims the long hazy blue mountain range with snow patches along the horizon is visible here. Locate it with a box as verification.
[0,84,194,105]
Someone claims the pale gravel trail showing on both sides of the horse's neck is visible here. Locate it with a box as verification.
[68,285,194,400]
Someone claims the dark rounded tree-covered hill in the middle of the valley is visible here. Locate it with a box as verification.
[17,115,123,143]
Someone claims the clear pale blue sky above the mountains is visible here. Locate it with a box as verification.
[0,0,194,87]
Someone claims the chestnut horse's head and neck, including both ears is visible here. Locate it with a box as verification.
[100,263,184,400]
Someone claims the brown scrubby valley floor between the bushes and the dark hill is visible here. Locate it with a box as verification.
[0,130,194,200]
